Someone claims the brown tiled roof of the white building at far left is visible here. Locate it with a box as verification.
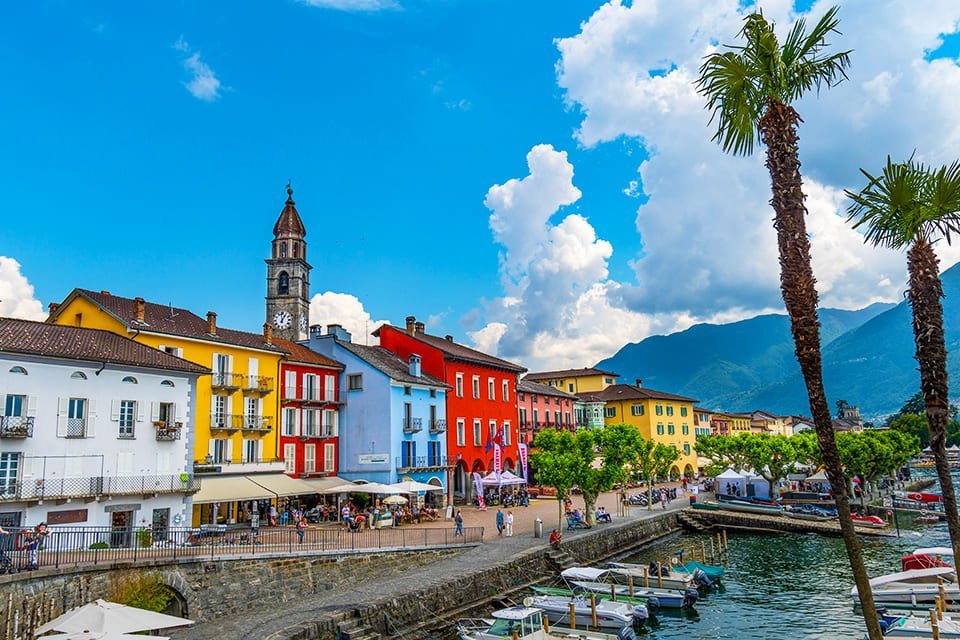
[0,318,210,374]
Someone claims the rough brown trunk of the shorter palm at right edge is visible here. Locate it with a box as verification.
[907,238,960,558]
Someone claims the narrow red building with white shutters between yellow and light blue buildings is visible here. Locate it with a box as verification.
[274,338,343,478]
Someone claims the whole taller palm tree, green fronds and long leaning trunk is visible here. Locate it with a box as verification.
[697,7,881,640]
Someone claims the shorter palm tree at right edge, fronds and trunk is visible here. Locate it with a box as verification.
[847,157,960,557]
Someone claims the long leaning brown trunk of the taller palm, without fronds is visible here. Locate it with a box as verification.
[760,102,883,640]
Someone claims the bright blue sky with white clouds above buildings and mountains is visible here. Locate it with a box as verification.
[0,0,960,366]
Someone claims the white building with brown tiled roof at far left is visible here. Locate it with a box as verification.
[0,318,209,544]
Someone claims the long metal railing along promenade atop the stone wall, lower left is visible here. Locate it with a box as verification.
[0,525,483,569]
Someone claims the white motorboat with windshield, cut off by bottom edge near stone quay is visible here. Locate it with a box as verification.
[457,606,637,640]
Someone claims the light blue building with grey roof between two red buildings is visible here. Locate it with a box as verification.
[308,324,450,504]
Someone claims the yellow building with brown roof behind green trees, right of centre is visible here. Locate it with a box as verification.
[596,384,696,477]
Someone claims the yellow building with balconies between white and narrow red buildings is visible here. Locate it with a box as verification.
[48,289,285,520]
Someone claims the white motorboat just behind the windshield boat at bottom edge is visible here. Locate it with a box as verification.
[523,594,650,633]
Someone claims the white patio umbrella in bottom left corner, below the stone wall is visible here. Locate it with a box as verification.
[34,600,193,637]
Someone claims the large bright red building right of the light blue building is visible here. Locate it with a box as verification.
[374,316,526,499]
